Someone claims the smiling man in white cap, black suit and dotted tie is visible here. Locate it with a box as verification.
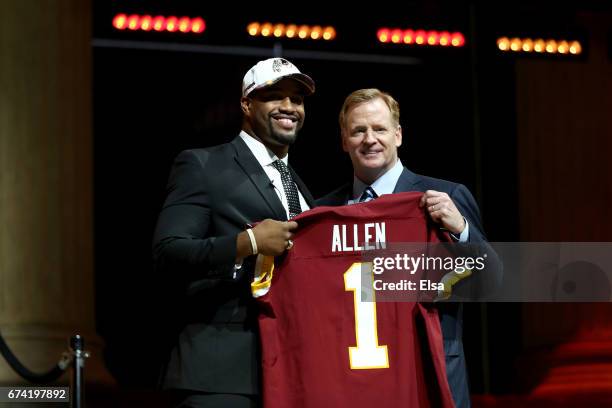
[153,58,315,407]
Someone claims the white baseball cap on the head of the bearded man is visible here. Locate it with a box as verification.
[242,58,315,96]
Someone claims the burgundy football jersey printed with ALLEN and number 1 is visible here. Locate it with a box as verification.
[252,193,454,408]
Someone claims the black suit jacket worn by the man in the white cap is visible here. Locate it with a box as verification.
[153,137,314,394]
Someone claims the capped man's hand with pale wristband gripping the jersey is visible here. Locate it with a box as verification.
[236,219,297,261]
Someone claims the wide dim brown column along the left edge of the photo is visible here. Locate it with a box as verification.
[0,0,111,385]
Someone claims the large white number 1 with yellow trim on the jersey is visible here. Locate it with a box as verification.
[344,263,389,370]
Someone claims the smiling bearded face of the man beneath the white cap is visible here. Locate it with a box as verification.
[241,79,306,158]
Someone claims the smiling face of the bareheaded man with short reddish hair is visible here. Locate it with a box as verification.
[342,98,402,184]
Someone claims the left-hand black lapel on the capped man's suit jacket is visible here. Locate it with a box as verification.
[228,136,287,220]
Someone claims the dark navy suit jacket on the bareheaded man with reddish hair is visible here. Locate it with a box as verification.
[317,168,502,408]
